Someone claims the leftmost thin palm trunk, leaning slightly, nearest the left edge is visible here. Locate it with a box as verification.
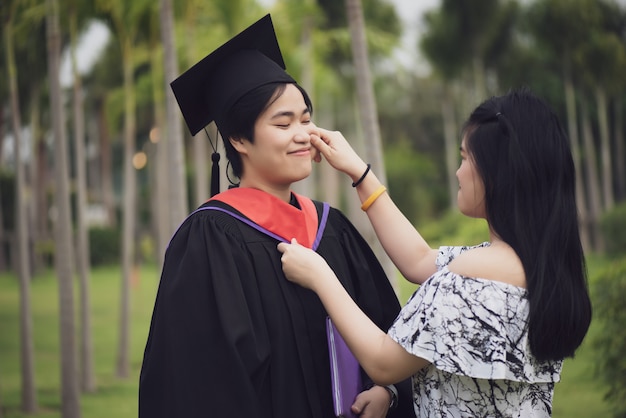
[4,15,37,414]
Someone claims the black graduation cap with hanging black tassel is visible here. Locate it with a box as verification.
[170,14,296,196]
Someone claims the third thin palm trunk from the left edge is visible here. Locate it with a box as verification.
[70,7,96,392]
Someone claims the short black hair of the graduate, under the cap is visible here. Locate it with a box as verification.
[217,83,313,178]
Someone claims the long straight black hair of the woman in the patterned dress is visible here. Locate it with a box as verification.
[464,90,591,360]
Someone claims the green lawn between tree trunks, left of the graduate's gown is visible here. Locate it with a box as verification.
[0,266,158,418]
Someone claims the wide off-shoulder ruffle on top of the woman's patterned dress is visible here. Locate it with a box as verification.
[389,247,562,383]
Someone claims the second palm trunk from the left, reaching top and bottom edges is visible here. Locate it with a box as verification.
[46,0,80,418]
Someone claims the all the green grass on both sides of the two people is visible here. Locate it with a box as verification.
[0,258,609,418]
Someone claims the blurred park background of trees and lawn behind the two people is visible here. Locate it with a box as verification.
[0,0,626,418]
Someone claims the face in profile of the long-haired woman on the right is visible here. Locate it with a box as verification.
[456,136,486,218]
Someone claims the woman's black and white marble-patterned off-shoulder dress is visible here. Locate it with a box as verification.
[388,243,562,418]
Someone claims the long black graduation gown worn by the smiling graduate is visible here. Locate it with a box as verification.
[139,190,414,418]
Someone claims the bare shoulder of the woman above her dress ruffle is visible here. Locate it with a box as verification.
[448,246,526,288]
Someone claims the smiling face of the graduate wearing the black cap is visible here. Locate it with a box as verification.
[231,84,315,189]
